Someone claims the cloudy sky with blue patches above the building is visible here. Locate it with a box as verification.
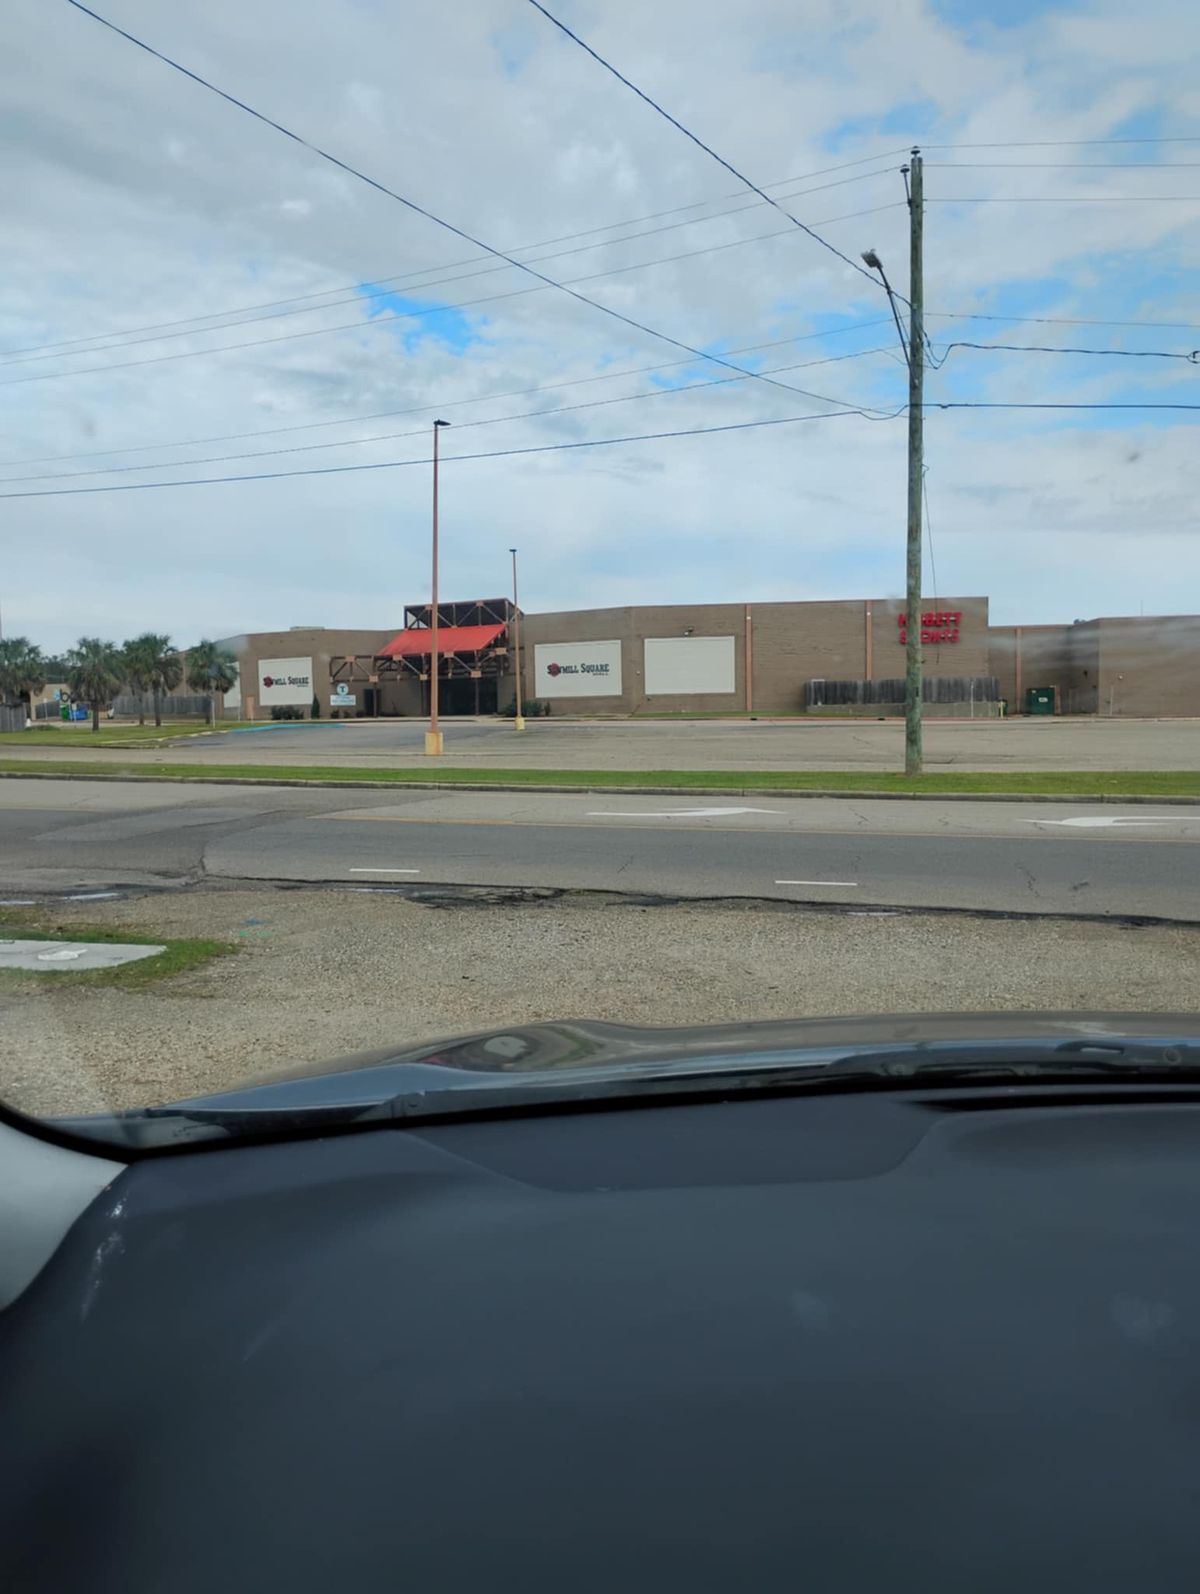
[0,0,1200,650]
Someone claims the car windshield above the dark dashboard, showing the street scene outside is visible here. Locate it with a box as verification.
[0,0,1200,1133]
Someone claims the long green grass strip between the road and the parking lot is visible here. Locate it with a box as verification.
[0,757,1200,799]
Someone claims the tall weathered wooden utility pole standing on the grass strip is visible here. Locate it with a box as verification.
[904,150,924,775]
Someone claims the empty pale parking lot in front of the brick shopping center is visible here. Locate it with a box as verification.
[9,717,1200,771]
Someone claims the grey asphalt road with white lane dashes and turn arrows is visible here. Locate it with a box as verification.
[0,779,1200,923]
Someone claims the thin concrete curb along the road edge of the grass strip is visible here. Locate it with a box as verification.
[0,770,1200,808]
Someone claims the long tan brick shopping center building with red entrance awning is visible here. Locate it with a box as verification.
[225,596,1200,719]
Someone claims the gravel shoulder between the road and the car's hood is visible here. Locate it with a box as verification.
[0,889,1200,1113]
